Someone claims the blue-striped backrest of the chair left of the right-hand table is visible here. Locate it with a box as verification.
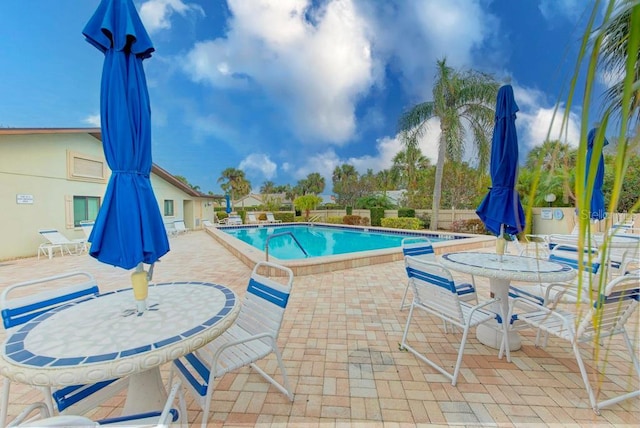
[404,256,464,324]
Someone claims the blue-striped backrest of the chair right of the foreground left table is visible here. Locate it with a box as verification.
[236,262,293,337]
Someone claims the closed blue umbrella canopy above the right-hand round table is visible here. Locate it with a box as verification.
[476,85,525,235]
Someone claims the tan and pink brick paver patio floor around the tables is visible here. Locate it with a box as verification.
[0,231,640,427]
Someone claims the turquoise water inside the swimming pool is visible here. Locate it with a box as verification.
[221,225,448,260]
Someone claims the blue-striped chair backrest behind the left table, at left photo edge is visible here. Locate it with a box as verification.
[0,272,100,329]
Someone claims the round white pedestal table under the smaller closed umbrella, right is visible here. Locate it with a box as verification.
[440,252,577,351]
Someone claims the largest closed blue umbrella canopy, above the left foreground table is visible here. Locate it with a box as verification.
[82,0,169,269]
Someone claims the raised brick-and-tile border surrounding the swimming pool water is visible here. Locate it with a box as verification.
[204,223,495,275]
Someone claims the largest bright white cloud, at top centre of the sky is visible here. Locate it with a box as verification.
[184,0,374,144]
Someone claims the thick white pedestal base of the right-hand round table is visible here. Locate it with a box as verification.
[476,278,521,351]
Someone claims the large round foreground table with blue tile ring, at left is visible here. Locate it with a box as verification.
[0,282,239,415]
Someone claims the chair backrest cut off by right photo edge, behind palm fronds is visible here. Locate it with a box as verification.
[576,271,640,338]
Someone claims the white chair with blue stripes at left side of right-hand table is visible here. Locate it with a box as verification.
[400,256,509,386]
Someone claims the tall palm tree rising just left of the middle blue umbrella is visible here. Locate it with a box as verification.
[399,58,499,229]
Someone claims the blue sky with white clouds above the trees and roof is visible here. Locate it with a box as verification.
[0,0,601,193]
